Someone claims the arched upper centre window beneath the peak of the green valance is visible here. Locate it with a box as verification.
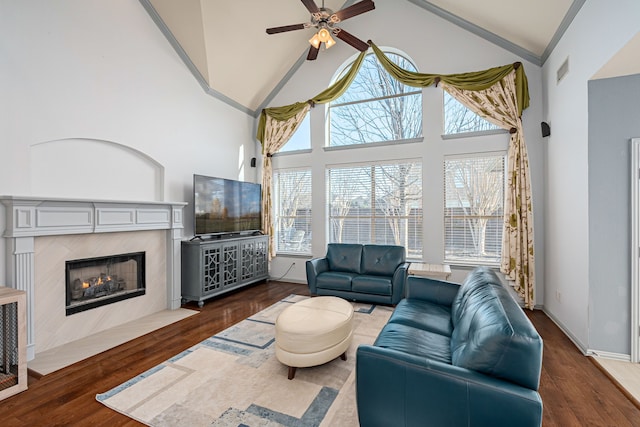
[328,53,422,146]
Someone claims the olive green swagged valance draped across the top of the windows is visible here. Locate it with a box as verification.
[256,40,529,147]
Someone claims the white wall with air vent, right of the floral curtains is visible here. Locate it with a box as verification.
[542,0,640,351]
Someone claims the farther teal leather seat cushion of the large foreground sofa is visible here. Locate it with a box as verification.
[389,299,453,337]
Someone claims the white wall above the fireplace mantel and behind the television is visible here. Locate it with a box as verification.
[0,0,256,281]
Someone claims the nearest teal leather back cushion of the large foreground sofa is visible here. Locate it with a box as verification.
[451,276,542,390]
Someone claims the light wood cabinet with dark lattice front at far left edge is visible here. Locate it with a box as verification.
[0,287,27,400]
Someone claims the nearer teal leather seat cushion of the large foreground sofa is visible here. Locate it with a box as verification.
[374,323,451,364]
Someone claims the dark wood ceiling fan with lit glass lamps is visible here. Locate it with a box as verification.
[267,0,375,61]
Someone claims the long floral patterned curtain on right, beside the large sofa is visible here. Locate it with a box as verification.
[442,69,535,309]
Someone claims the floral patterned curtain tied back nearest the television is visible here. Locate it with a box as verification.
[262,103,311,257]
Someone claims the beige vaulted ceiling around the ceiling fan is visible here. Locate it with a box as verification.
[140,0,632,115]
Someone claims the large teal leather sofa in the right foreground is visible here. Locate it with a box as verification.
[356,268,543,427]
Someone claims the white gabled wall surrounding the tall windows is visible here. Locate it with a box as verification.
[264,0,544,304]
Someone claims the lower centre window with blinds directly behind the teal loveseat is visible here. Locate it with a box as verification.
[327,161,422,259]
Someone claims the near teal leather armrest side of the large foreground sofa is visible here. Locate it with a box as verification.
[356,345,542,427]
